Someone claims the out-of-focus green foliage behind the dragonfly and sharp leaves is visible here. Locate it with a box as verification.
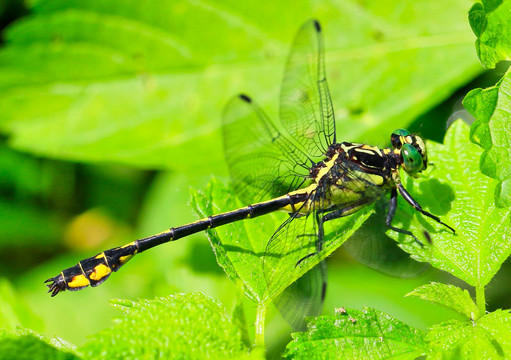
[0,0,511,358]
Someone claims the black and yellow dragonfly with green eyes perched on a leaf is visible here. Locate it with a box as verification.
[45,20,455,310]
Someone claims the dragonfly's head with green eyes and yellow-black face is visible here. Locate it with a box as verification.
[390,129,428,175]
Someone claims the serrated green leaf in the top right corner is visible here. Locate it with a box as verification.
[468,0,511,69]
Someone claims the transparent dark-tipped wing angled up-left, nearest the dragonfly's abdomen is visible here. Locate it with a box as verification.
[222,95,312,204]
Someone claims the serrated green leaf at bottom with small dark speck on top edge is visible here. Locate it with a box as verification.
[286,308,426,359]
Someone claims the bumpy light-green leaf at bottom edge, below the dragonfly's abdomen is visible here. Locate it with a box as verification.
[80,293,252,359]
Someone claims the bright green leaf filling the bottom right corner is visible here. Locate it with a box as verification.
[426,310,511,360]
